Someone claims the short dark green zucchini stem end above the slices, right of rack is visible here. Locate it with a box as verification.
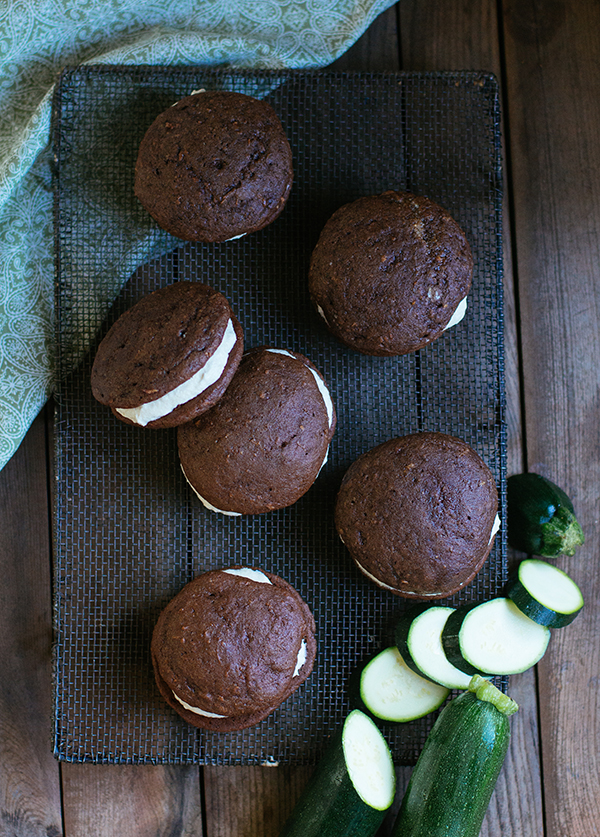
[506,473,585,558]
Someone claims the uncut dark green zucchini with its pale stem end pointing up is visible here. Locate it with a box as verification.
[392,677,518,837]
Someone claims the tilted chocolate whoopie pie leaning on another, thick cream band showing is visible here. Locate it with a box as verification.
[91,282,244,428]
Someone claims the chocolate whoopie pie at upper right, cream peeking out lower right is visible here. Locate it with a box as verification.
[309,191,473,355]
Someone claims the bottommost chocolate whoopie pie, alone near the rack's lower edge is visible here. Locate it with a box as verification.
[151,567,316,732]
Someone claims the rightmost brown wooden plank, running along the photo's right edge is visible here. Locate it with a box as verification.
[504,0,600,837]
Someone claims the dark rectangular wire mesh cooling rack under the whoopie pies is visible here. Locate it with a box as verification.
[53,66,506,764]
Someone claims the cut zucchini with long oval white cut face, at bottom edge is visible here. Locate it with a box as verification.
[280,709,396,837]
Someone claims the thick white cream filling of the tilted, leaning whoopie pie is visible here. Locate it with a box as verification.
[116,320,237,427]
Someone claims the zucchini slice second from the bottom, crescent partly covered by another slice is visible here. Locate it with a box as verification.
[394,605,486,689]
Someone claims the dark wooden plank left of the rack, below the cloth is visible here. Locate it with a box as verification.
[0,415,62,837]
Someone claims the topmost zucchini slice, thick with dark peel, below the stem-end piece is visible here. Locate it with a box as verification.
[505,558,583,628]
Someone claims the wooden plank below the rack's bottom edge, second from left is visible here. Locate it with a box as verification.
[62,764,204,837]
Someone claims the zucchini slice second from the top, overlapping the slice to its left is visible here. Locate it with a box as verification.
[442,597,550,675]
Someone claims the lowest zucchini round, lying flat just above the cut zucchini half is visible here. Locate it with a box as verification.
[359,646,448,723]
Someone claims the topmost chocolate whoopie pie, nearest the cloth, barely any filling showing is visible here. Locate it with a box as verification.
[135,90,293,241]
